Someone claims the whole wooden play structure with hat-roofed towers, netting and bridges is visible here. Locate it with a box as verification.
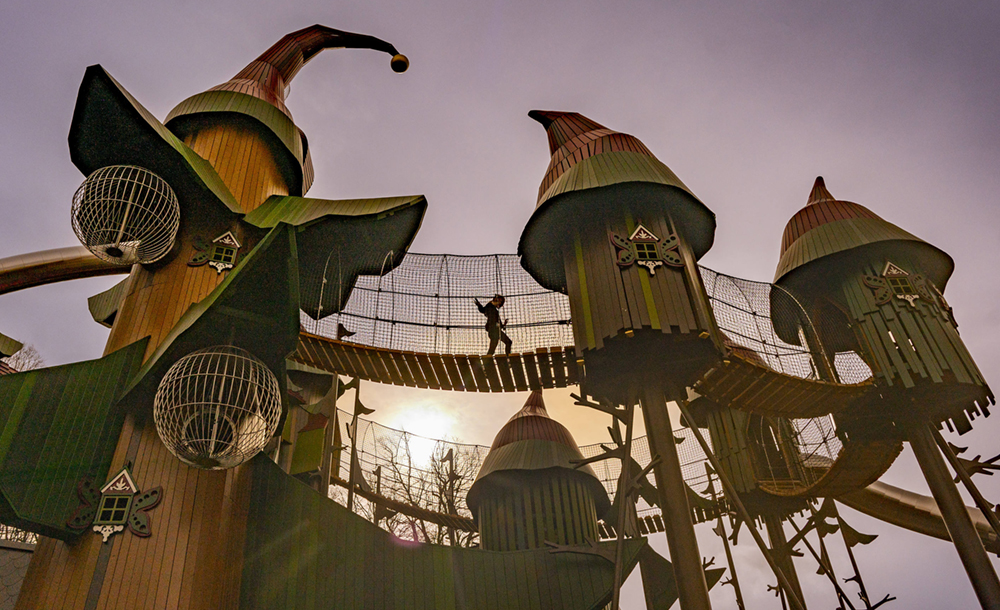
[0,26,1000,610]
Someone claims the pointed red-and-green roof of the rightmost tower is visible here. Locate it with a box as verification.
[774,176,955,291]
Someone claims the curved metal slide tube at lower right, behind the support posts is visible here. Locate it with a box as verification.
[837,481,1000,554]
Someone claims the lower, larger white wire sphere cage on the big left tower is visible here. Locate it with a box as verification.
[153,345,281,470]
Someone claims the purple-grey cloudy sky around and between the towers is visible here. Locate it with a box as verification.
[0,0,1000,608]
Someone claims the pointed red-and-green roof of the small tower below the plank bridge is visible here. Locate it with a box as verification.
[467,390,611,515]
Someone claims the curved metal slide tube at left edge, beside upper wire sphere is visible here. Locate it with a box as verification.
[0,246,132,294]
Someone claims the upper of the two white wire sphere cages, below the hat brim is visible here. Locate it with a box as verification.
[73,165,181,265]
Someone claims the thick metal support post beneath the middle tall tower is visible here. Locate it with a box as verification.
[642,386,712,610]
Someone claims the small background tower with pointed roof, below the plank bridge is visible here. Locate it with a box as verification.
[468,390,611,551]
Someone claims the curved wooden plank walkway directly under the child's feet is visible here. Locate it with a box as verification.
[291,331,580,392]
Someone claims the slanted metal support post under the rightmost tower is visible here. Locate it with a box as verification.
[909,424,1000,610]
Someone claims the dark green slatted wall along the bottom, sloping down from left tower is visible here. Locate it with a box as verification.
[240,456,643,610]
